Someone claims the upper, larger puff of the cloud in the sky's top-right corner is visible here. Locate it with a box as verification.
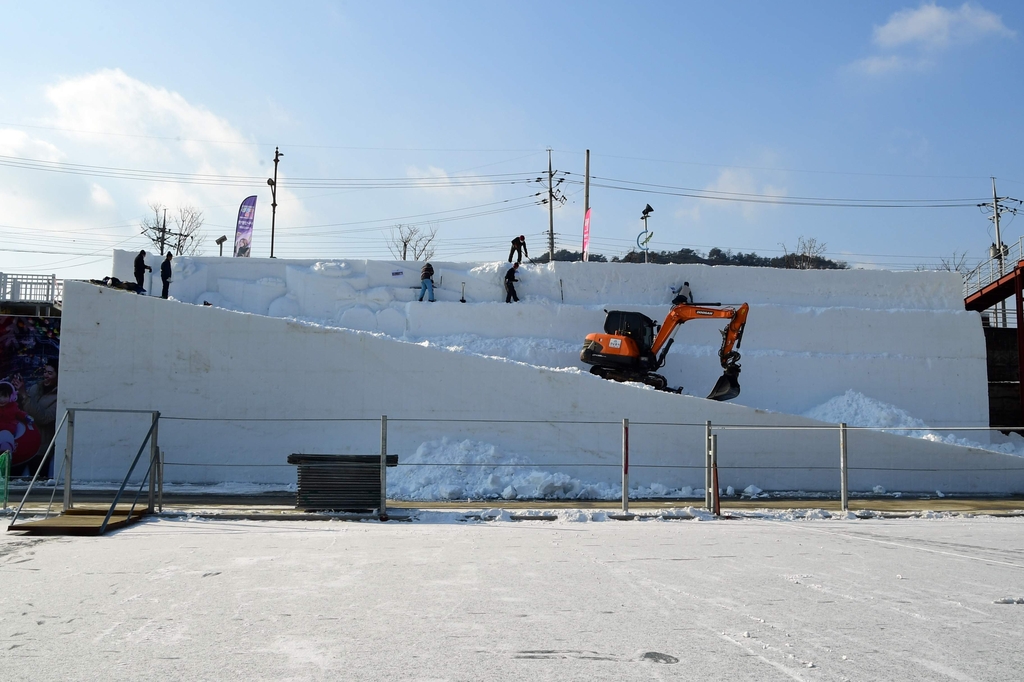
[874,3,1016,49]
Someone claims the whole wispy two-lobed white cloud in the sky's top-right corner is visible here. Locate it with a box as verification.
[851,3,1017,76]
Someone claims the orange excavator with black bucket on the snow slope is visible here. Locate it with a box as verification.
[580,303,750,400]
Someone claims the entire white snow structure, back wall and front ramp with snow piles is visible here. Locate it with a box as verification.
[54,252,1024,493]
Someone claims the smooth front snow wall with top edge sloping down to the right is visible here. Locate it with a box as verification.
[60,282,1024,493]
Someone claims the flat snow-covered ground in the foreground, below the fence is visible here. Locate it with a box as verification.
[0,514,1024,681]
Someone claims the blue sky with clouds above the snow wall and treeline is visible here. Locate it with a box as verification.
[0,0,1024,278]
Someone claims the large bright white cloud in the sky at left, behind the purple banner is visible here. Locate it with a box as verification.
[0,69,309,275]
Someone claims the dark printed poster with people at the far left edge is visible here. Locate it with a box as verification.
[0,315,60,477]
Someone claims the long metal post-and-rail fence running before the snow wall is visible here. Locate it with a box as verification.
[14,410,1024,518]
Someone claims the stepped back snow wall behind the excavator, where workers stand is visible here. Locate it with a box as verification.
[114,251,988,426]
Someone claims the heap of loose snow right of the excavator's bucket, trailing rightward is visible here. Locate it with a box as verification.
[804,390,1024,456]
